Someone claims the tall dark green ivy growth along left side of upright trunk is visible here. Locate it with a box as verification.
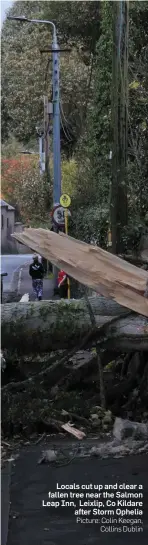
[73,2,112,207]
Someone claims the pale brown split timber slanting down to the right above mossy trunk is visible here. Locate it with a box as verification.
[13,228,148,316]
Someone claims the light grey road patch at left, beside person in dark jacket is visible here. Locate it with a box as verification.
[1,254,32,292]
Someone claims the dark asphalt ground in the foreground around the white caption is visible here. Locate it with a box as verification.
[2,439,148,545]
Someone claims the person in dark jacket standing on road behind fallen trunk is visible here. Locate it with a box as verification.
[29,256,44,301]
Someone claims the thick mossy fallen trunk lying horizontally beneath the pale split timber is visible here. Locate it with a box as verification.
[1,297,148,355]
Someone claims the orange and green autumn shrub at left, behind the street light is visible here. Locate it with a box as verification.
[2,155,51,227]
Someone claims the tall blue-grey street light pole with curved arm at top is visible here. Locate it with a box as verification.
[7,15,61,205]
